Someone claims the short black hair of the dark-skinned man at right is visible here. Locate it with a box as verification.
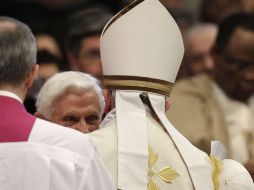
[215,13,254,51]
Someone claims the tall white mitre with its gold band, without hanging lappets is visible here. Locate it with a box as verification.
[100,0,184,96]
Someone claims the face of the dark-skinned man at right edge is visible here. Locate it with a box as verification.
[213,21,254,102]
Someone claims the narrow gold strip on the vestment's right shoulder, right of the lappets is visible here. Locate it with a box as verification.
[210,156,222,190]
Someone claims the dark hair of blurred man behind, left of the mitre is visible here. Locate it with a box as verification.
[65,8,112,55]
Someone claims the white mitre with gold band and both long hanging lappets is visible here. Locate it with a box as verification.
[100,0,213,190]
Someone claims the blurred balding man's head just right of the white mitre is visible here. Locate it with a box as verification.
[177,23,217,79]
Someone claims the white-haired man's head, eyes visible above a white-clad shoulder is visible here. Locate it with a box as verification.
[35,71,105,133]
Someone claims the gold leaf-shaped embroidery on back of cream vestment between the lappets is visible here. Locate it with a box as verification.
[147,146,179,190]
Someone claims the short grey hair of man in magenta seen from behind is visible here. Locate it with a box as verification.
[0,17,36,86]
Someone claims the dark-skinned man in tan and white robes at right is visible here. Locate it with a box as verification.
[167,14,254,178]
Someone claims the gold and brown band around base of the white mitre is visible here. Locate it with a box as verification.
[103,75,173,96]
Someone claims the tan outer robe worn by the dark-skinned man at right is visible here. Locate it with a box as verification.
[166,75,254,161]
